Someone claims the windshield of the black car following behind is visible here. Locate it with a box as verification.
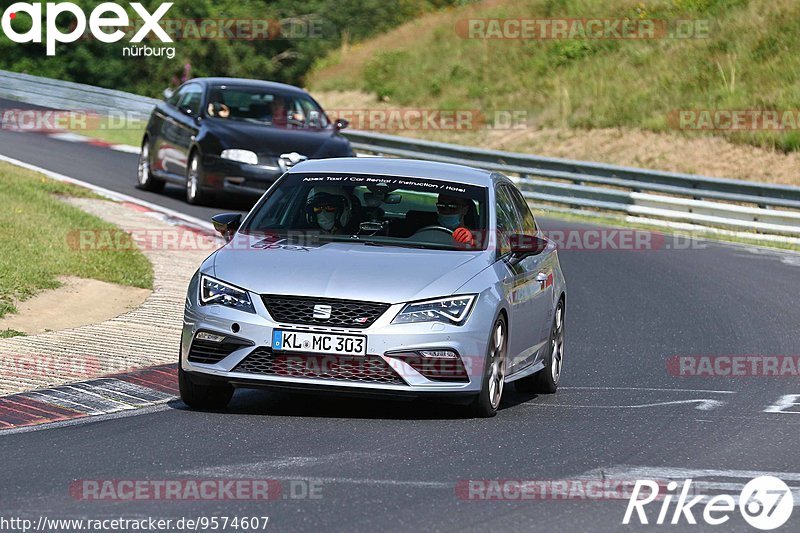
[207,85,329,128]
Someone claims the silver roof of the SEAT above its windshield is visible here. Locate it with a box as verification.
[289,157,493,187]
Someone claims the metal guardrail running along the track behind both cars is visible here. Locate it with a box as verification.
[0,70,800,237]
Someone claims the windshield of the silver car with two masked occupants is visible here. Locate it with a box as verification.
[242,173,488,250]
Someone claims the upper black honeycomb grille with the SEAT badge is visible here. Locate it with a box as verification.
[261,295,389,328]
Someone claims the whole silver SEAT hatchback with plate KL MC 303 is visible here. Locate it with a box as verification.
[179,158,566,417]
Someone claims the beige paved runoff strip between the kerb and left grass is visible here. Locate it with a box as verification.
[0,198,218,395]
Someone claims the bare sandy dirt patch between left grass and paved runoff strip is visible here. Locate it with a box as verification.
[0,277,151,335]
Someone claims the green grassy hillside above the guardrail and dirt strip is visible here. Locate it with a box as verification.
[307,0,800,151]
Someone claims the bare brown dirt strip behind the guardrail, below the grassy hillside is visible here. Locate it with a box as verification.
[314,91,800,185]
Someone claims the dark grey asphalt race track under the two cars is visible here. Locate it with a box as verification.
[0,97,800,531]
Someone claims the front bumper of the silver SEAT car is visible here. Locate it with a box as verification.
[180,276,495,397]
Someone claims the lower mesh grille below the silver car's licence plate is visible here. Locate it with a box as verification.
[233,347,406,385]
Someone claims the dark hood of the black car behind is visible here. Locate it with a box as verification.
[207,118,350,159]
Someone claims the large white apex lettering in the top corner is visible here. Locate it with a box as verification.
[0,2,172,56]
